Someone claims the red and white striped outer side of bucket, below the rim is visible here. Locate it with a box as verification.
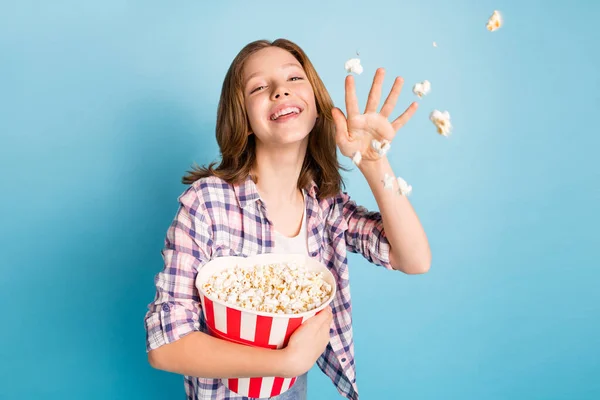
[200,295,314,398]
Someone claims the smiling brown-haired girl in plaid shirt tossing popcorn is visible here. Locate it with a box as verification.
[145,39,431,400]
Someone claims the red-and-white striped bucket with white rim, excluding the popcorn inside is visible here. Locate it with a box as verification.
[196,254,336,398]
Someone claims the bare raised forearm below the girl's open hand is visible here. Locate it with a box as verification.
[359,157,431,274]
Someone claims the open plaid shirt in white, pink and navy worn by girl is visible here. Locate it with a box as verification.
[145,177,391,400]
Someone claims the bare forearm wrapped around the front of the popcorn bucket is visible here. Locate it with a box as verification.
[148,332,295,378]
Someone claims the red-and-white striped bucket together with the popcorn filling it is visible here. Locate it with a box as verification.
[196,254,336,398]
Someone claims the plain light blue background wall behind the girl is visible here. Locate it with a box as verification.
[0,0,600,400]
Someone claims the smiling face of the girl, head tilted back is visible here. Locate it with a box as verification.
[243,47,317,145]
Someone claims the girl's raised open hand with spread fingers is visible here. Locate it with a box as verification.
[332,68,418,161]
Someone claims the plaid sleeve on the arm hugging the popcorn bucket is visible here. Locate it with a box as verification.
[145,187,212,351]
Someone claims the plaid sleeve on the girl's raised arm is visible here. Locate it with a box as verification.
[340,192,393,269]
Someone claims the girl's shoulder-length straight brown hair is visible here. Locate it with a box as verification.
[182,39,347,199]
